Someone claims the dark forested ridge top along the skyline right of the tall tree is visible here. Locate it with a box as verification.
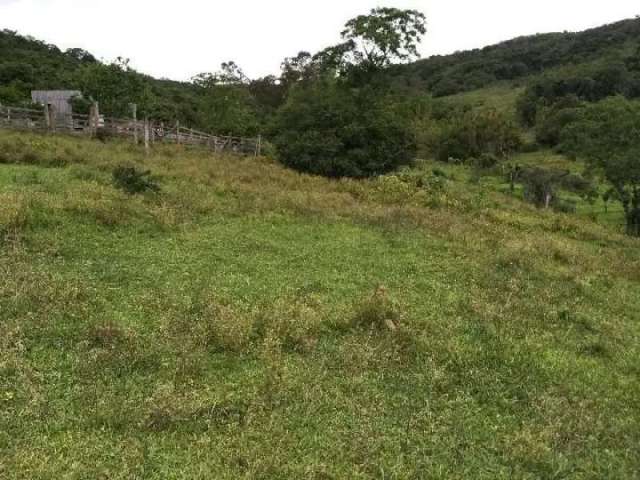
[394,17,640,96]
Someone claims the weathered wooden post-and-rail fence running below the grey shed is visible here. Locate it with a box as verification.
[0,105,262,156]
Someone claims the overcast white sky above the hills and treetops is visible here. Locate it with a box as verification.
[0,0,640,80]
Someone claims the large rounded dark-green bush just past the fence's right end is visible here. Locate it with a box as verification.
[274,81,416,178]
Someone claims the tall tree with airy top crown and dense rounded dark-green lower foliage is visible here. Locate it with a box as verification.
[273,8,425,177]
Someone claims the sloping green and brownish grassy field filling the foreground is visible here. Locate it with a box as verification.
[0,132,640,479]
